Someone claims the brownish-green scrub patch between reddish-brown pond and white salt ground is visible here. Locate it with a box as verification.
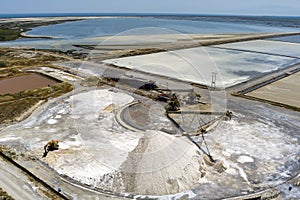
[0,82,73,123]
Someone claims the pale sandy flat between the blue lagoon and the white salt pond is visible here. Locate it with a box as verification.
[85,31,300,47]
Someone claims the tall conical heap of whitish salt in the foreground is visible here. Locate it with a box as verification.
[121,131,205,195]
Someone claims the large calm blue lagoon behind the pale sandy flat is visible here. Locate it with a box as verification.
[27,17,297,39]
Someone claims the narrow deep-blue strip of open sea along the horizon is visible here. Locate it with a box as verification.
[0,13,300,30]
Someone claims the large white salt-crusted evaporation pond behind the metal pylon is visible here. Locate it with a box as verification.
[103,47,300,87]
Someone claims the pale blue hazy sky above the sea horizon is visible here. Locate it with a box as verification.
[0,0,300,16]
